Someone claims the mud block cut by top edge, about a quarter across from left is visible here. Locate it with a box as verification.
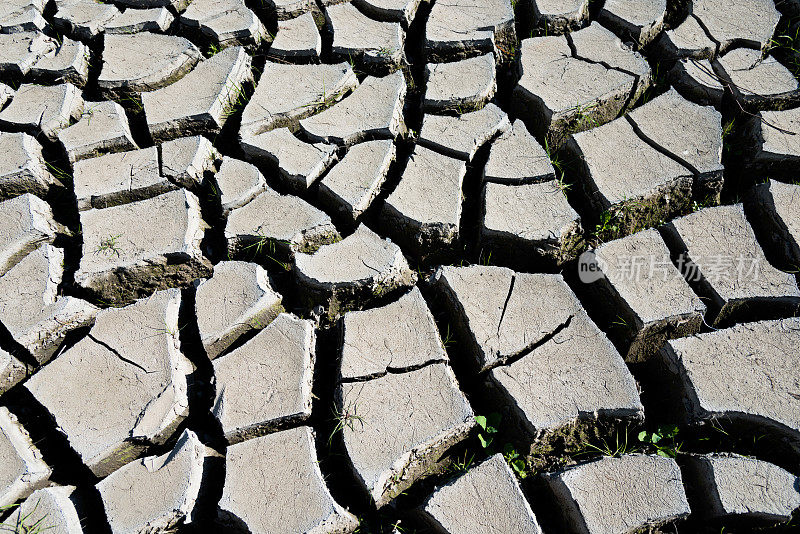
[178,0,268,48]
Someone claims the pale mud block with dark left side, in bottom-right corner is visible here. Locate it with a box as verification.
[687,454,800,522]
